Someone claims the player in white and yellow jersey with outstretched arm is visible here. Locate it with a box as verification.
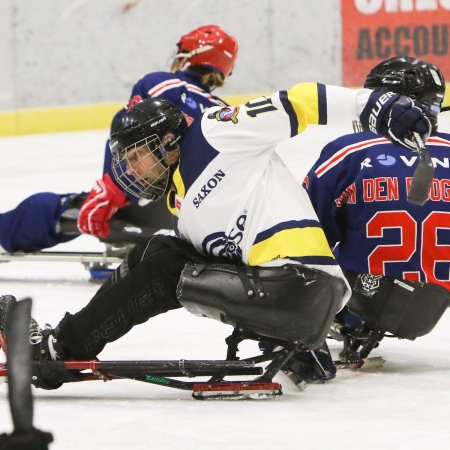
[3,79,431,389]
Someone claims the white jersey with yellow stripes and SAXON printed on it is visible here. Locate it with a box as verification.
[170,83,371,304]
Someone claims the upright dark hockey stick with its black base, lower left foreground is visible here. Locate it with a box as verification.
[0,298,53,450]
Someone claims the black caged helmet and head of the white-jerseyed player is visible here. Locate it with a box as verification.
[109,98,188,201]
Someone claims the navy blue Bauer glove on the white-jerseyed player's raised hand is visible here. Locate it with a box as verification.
[360,89,431,150]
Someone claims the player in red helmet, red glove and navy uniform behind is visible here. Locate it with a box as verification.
[0,25,238,253]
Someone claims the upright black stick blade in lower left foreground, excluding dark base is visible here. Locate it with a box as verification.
[6,298,33,431]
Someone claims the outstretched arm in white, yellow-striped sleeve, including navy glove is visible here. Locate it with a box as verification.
[202,83,430,157]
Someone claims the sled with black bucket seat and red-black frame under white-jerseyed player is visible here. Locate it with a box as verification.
[0,263,358,400]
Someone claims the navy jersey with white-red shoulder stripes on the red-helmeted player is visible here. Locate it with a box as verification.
[103,71,226,201]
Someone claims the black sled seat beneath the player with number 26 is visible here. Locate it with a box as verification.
[330,272,450,361]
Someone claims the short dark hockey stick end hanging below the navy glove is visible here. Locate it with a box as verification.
[407,132,434,206]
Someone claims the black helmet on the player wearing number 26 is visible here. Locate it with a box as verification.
[364,56,445,125]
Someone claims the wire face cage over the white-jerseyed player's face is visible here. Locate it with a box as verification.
[111,134,171,201]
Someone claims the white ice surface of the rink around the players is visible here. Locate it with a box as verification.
[0,120,450,450]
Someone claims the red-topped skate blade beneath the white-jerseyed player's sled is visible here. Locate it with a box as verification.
[192,381,283,400]
